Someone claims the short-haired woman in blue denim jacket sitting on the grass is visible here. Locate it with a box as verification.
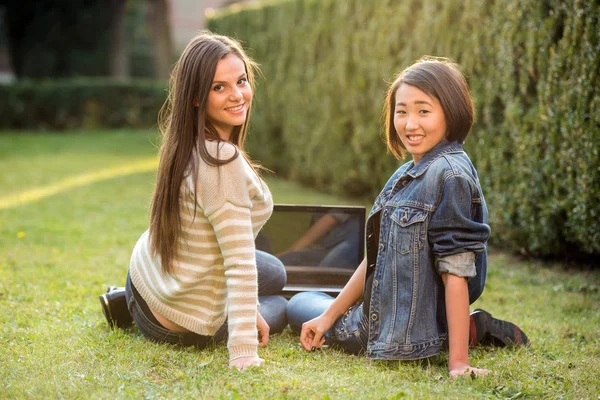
[287,57,528,376]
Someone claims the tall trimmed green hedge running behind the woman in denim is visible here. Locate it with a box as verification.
[209,0,600,257]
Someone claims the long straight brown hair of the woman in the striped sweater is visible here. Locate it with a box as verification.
[150,31,257,273]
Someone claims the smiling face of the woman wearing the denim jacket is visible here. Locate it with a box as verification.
[394,83,446,164]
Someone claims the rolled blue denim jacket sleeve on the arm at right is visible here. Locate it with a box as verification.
[428,175,490,259]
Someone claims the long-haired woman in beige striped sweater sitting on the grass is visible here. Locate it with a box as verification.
[101,32,287,369]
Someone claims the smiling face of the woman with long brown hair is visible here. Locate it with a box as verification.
[206,54,252,141]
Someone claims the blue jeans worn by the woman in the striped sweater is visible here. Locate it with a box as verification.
[125,250,287,349]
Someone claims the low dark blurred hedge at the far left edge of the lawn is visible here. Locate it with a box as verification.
[0,78,166,130]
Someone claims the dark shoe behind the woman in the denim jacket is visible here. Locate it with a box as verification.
[469,308,529,347]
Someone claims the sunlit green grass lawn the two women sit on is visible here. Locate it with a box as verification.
[0,131,600,399]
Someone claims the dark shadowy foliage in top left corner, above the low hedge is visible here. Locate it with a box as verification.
[0,0,108,78]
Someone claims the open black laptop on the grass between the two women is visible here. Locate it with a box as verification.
[255,204,366,298]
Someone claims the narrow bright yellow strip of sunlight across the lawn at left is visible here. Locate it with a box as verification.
[0,157,158,210]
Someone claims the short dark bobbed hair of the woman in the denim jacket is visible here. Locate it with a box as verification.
[384,56,475,158]
